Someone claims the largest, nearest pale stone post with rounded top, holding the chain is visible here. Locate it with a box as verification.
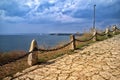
[28,40,38,66]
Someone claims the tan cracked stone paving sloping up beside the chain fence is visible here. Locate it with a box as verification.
[3,35,120,80]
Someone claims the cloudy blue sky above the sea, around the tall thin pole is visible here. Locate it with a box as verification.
[0,0,120,34]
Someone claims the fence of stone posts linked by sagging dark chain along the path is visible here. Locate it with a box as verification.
[0,24,120,66]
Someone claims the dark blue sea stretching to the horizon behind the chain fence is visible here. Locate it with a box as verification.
[0,34,69,52]
